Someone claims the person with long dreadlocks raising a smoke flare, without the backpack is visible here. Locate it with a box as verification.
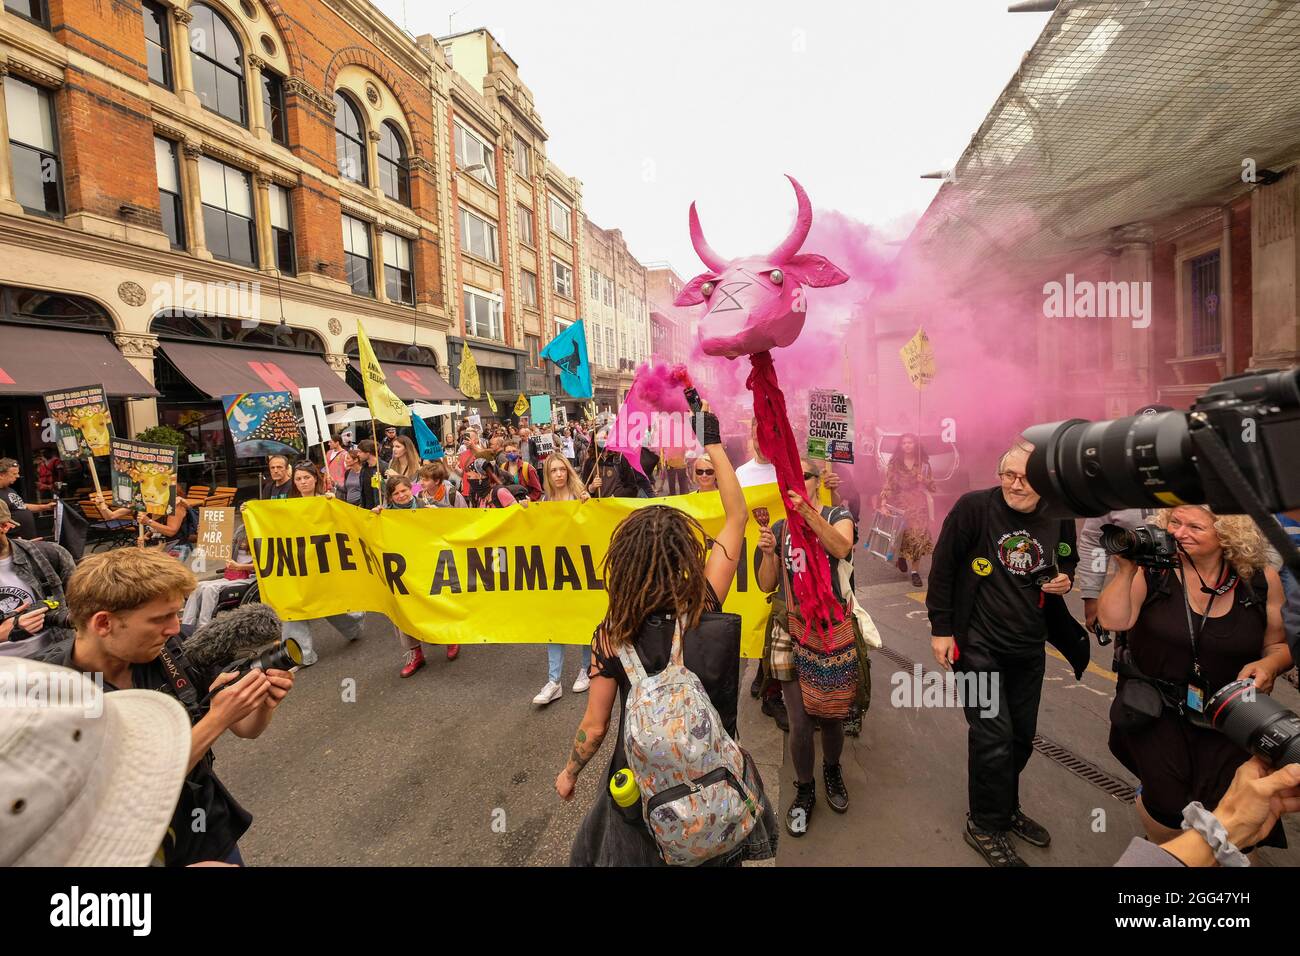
[555,403,776,866]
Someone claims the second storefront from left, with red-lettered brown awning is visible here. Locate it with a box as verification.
[150,312,363,489]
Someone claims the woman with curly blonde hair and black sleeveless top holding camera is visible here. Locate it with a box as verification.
[1097,505,1292,847]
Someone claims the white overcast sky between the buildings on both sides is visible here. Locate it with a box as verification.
[377,0,1048,278]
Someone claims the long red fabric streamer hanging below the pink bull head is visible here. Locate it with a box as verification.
[745,351,844,649]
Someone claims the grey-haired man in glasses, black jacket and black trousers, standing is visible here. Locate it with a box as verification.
[926,441,1087,866]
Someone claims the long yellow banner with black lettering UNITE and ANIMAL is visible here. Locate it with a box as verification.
[244,485,785,657]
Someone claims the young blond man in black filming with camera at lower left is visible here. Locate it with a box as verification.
[40,548,294,866]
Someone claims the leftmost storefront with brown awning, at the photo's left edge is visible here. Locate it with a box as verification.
[0,286,157,502]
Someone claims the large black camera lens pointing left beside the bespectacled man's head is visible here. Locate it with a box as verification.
[1024,411,1205,516]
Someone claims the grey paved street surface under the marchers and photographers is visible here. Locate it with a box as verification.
[216,551,1300,866]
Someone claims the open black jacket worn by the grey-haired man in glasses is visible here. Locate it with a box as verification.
[926,488,1092,679]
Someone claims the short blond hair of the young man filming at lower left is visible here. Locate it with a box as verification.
[68,548,198,631]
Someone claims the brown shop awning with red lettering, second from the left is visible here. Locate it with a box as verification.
[161,342,361,405]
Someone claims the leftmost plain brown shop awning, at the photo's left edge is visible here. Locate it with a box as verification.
[0,325,159,398]
